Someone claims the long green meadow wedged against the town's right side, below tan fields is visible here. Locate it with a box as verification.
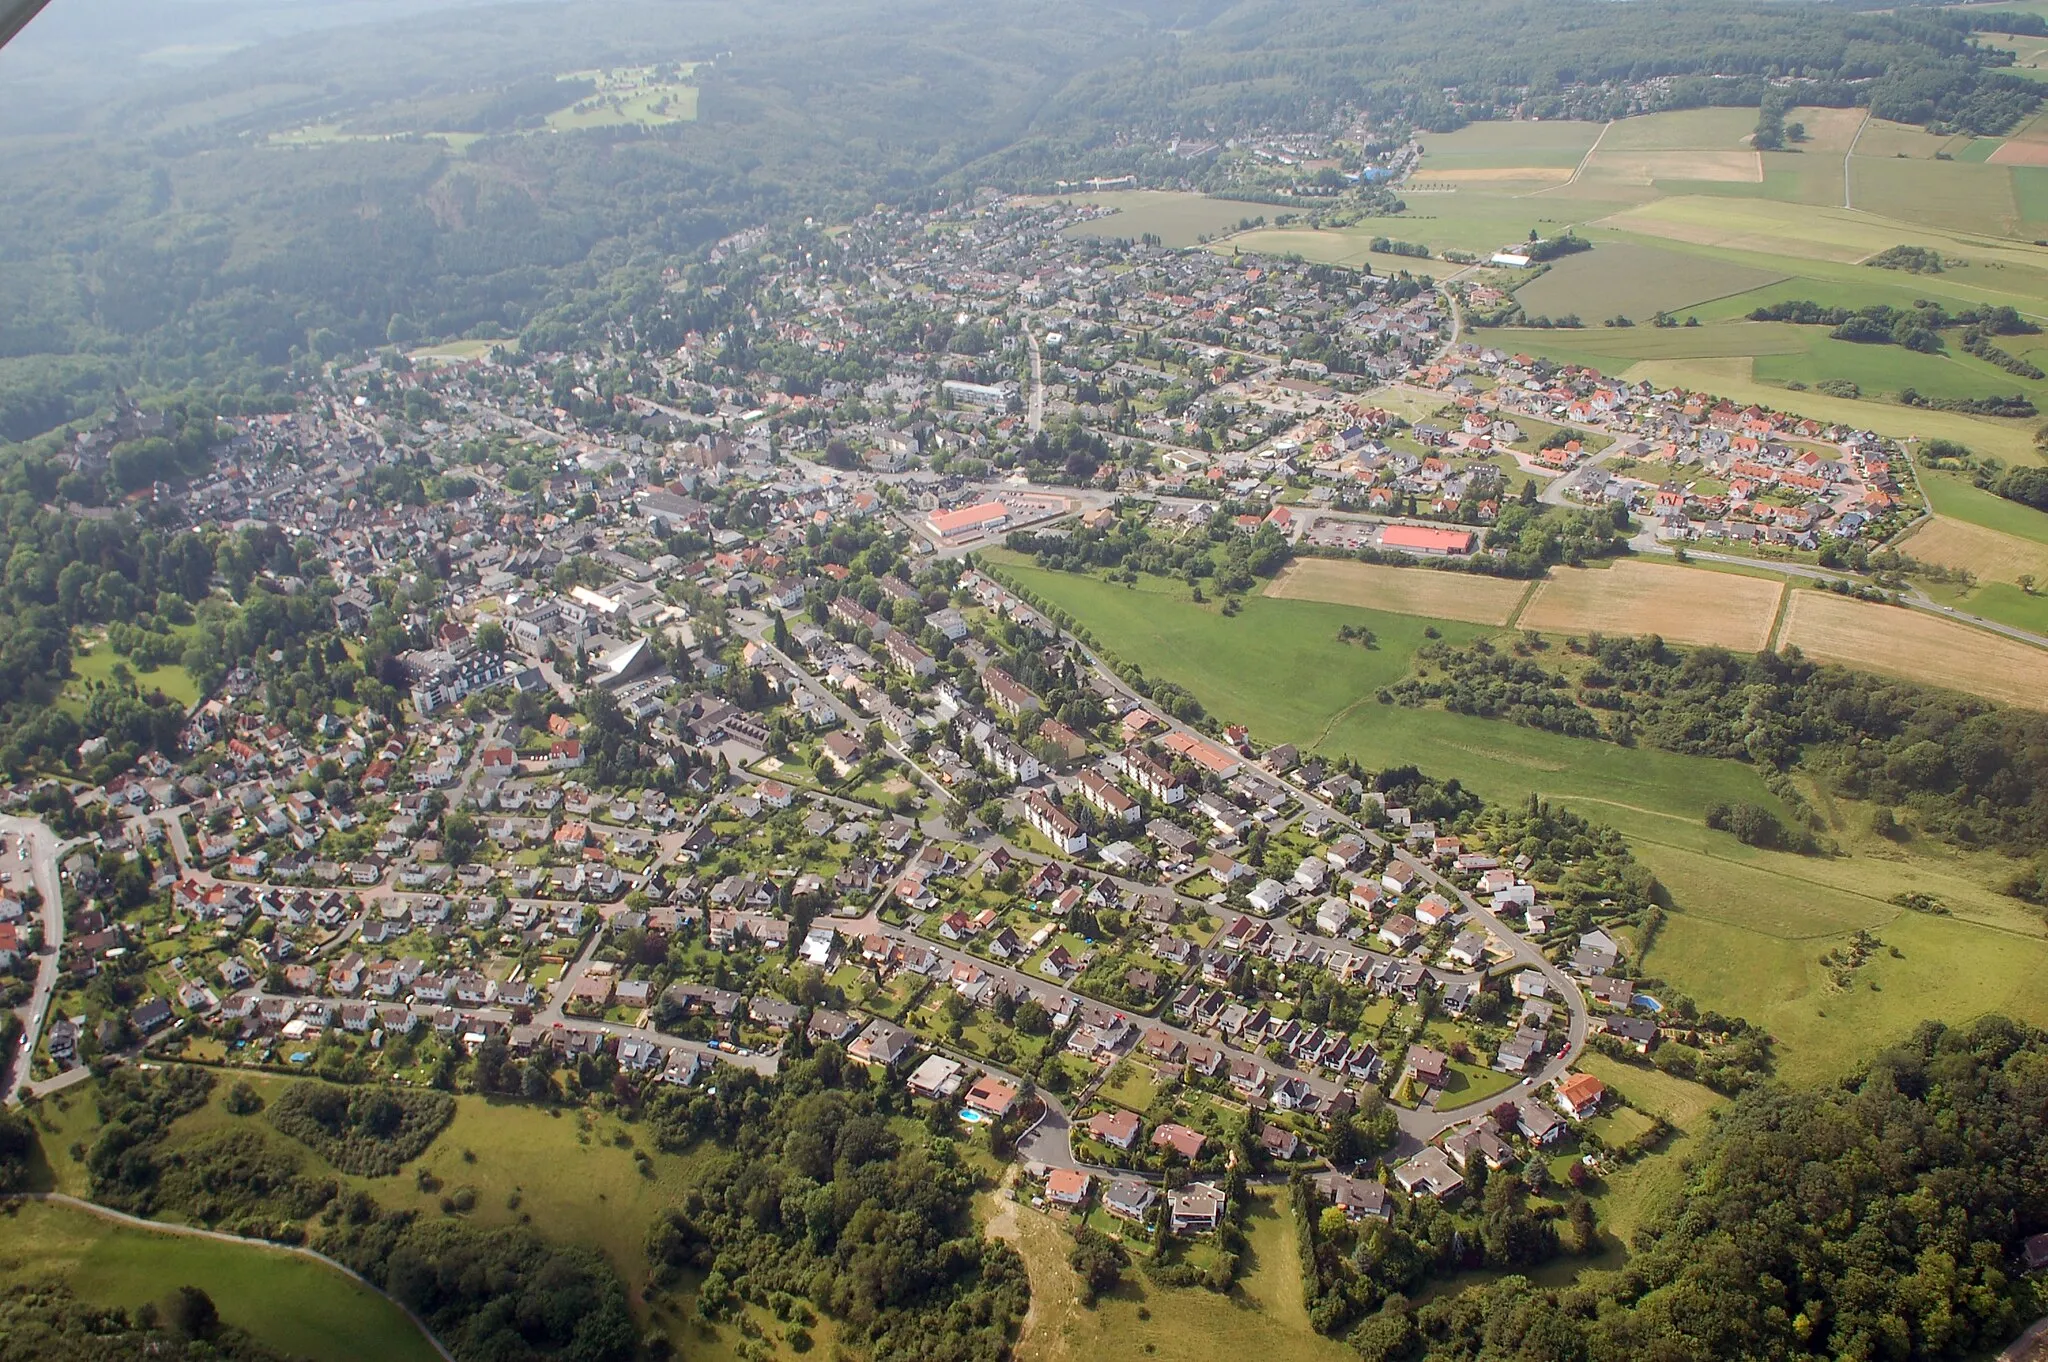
[989,555,2048,1079]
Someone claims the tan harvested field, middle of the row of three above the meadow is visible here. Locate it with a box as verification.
[1520,561,1784,651]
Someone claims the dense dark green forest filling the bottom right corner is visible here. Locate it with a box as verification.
[1351,1016,2048,1362]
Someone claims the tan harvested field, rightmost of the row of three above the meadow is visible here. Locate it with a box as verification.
[1780,590,2048,709]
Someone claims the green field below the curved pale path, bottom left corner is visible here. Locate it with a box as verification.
[0,1202,436,1362]
